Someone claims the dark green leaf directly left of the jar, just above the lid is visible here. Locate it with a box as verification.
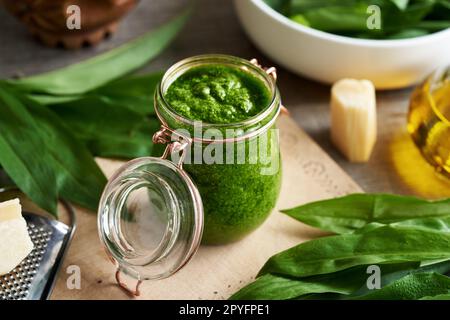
[49,97,162,158]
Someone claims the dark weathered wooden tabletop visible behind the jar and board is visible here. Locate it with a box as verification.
[0,0,450,197]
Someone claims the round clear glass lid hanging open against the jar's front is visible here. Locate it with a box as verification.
[98,157,203,292]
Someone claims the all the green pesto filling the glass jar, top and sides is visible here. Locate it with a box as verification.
[164,65,281,244]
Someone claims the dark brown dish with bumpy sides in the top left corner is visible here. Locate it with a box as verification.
[0,0,138,49]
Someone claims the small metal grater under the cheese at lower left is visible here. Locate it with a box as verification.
[0,189,75,300]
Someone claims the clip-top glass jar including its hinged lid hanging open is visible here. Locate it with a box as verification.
[98,55,281,296]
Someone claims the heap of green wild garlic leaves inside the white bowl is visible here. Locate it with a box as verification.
[274,0,450,39]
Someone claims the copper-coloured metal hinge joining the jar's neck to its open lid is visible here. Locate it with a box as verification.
[152,125,192,168]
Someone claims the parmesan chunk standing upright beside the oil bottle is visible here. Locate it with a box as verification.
[331,79,377,162]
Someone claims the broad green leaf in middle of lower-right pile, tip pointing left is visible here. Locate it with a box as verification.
[259,226,450,277]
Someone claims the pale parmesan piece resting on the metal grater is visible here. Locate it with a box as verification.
[0,199,33,275]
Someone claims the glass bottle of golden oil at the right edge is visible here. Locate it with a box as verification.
[408,67,450,178]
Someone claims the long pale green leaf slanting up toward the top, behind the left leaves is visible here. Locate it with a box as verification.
[6,11,190,95]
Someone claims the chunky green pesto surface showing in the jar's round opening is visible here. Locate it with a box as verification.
[164,65,271,124]
